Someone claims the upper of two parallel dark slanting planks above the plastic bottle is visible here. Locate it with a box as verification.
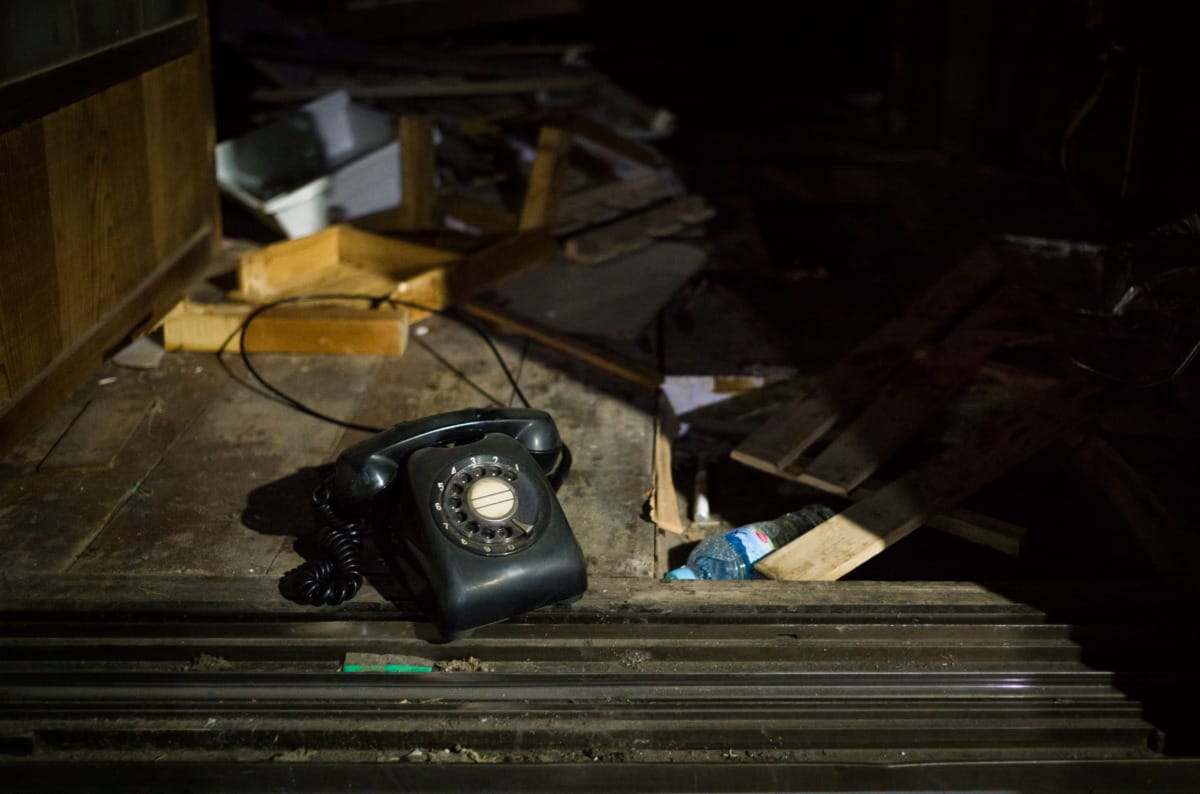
[732,243,1001,473]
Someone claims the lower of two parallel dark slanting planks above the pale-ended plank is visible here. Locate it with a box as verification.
[802,332,1001,497]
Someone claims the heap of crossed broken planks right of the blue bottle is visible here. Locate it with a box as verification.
[732,245,1113,579]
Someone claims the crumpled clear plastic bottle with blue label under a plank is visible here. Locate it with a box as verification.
[662,505,834,581]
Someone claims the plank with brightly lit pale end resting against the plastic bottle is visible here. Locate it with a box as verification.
[755,390,1094,581]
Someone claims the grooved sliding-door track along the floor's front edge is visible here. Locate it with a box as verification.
[0,585,1198,792]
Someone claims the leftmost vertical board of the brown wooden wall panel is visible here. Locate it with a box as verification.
[0,122,64,393]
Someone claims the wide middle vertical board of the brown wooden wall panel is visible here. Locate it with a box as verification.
[43,79,156,343]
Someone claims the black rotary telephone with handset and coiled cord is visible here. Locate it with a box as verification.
[299,408,587,638]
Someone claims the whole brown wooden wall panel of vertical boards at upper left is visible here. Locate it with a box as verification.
[0,4,220,450]
